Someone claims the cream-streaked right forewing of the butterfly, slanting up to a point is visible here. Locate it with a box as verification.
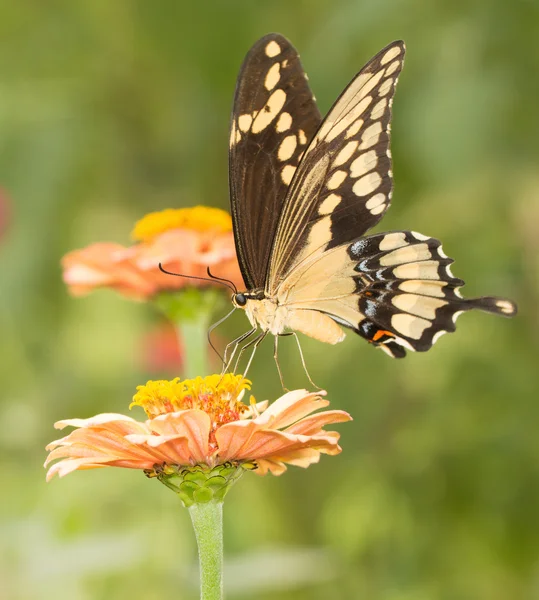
[266,41,405,295]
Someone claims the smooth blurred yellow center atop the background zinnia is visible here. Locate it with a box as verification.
[131,206,232,242]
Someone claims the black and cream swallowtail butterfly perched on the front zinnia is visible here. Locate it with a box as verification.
[229,33,516,370]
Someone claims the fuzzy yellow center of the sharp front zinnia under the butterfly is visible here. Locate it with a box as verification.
[130,374,251,424]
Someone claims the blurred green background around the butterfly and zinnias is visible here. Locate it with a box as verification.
[0,0,539,600]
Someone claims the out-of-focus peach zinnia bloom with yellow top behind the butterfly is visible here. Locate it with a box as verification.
[62,206,243,299]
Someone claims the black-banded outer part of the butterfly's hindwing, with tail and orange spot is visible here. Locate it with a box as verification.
[348,231,516,358]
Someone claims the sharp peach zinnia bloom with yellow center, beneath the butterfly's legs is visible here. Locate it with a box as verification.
[45,374,351,480]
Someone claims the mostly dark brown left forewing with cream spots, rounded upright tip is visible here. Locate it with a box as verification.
[229,34,321,290]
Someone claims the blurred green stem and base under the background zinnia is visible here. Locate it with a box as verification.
[155,287,224,379]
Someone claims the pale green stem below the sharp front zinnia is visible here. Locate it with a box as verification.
[189,501,223,600]
